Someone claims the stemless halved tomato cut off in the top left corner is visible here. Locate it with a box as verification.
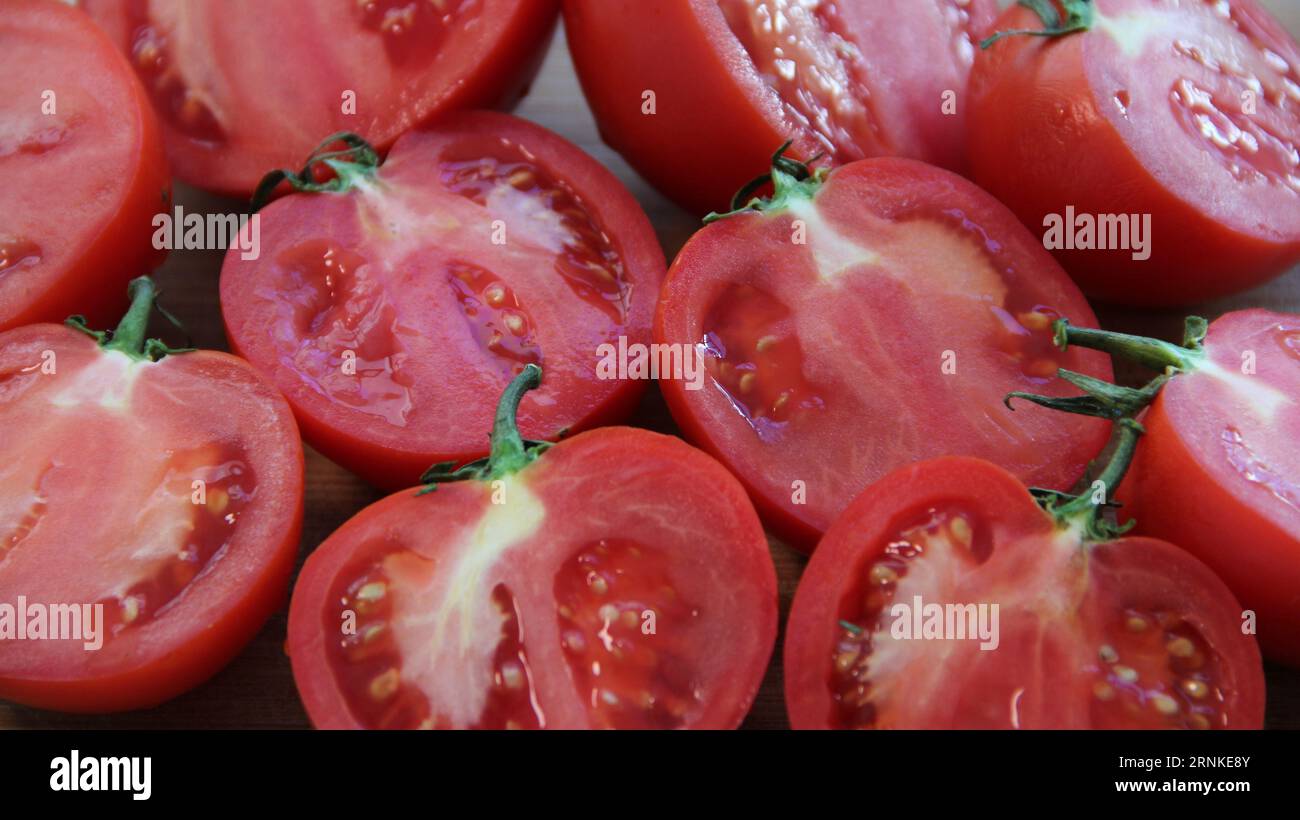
[0,0,170,330]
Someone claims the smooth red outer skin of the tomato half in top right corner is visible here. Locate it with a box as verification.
[967,0,1300,308]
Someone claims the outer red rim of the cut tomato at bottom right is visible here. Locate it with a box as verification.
[783,457,1265,729]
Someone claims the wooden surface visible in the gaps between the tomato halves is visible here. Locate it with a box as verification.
[0,12,1300,729]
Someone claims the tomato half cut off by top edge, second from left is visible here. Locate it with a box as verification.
[82,0,559,196]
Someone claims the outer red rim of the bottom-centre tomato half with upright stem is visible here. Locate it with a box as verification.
[287,428,777,729]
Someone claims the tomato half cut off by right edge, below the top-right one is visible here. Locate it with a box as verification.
[1127,311,1300,665]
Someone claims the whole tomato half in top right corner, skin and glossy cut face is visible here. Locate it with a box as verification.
[969,0,1300,305]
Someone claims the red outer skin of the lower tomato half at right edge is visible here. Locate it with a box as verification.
[1125,309,1300,667]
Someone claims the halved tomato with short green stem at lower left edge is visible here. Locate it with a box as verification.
[0,279,303,712]
